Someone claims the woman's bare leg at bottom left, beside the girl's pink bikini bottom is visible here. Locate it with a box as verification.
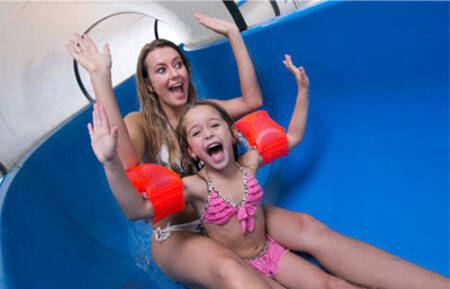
[152,232,272,289]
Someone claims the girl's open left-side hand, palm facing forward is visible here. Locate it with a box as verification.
[88,104,118,164]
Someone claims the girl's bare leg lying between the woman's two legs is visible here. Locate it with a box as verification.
[275,252,362,289]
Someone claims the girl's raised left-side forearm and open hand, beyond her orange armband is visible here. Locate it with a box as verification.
[88,104,153,220]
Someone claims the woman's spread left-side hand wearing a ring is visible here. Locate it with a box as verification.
[65,33,111,73]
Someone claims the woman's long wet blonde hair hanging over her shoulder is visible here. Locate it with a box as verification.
[136,39,197,168]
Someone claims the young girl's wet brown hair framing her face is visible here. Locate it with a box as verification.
[177,100,238,174]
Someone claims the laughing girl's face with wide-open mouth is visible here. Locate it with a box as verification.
[183,105,237,170]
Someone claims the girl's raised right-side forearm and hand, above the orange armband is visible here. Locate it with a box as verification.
[283,54,309,150]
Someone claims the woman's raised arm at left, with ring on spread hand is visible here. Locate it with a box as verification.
[66,34,145,169]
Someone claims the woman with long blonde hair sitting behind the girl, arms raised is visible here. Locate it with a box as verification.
[66,14,449,289]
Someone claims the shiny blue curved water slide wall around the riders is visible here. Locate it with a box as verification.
[0,2,449,288]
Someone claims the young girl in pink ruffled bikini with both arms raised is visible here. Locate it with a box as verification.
[89,55,366,288]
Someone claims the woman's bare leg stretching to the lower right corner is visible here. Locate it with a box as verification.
[264,206,450,289]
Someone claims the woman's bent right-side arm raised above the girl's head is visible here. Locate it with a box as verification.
[195,13,263,119]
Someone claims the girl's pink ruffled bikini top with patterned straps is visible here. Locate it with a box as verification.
[202,166,263,234]
